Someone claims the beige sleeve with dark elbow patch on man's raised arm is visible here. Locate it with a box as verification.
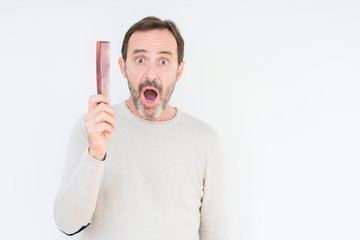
[54,117,105,235]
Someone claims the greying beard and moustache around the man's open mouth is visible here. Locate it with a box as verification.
[126,75,176,120]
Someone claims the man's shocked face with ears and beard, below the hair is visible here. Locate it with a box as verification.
[119,29,184,119]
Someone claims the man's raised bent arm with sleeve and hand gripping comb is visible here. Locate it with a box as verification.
[54,94,115,235]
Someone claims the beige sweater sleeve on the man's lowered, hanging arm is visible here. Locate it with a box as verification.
[199,134,228,240]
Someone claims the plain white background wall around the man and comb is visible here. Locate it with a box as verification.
[0,0,360,240]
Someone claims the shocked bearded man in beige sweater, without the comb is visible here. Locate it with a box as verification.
[54,17,227,240]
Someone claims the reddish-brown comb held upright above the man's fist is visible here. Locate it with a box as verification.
[96,41,110,96]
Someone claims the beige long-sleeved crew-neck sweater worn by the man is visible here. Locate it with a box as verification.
[54,102,228,240]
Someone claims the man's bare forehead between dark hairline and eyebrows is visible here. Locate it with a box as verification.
[128,29,177,57]
